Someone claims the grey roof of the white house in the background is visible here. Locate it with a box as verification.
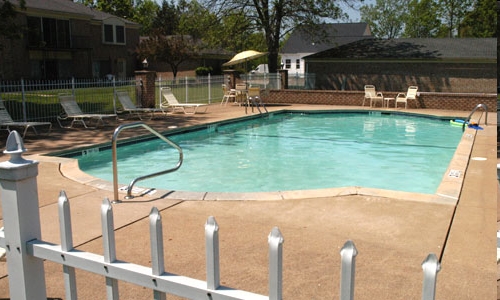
[280,23,371,53]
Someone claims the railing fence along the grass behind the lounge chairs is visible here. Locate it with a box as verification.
[0,73,314,122]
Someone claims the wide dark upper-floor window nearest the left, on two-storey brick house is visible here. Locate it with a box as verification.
[28,17,71,48]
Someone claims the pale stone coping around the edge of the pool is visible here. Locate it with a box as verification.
[33,108,476,205]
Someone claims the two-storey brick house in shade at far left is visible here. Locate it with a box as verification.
[0,0,140,80]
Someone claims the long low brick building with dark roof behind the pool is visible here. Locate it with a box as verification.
[304,38,497,93]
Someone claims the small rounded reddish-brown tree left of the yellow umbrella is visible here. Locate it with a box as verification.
[136,31,199,78]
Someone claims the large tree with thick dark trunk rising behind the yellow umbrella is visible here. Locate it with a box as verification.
[204,0,354,72]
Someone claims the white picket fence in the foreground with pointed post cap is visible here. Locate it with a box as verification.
[0,131,440,300]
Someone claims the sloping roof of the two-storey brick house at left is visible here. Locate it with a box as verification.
[10,0,137,25]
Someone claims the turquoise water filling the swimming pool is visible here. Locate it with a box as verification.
[78,113,462,194]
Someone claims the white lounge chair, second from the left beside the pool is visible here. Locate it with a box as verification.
[57,95,118,128]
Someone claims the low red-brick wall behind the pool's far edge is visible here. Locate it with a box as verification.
[263,90,497,112]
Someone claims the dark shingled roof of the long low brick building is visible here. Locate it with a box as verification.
[304,38,497,61]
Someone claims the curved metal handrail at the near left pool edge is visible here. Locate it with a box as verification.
[112,122,184,202]
